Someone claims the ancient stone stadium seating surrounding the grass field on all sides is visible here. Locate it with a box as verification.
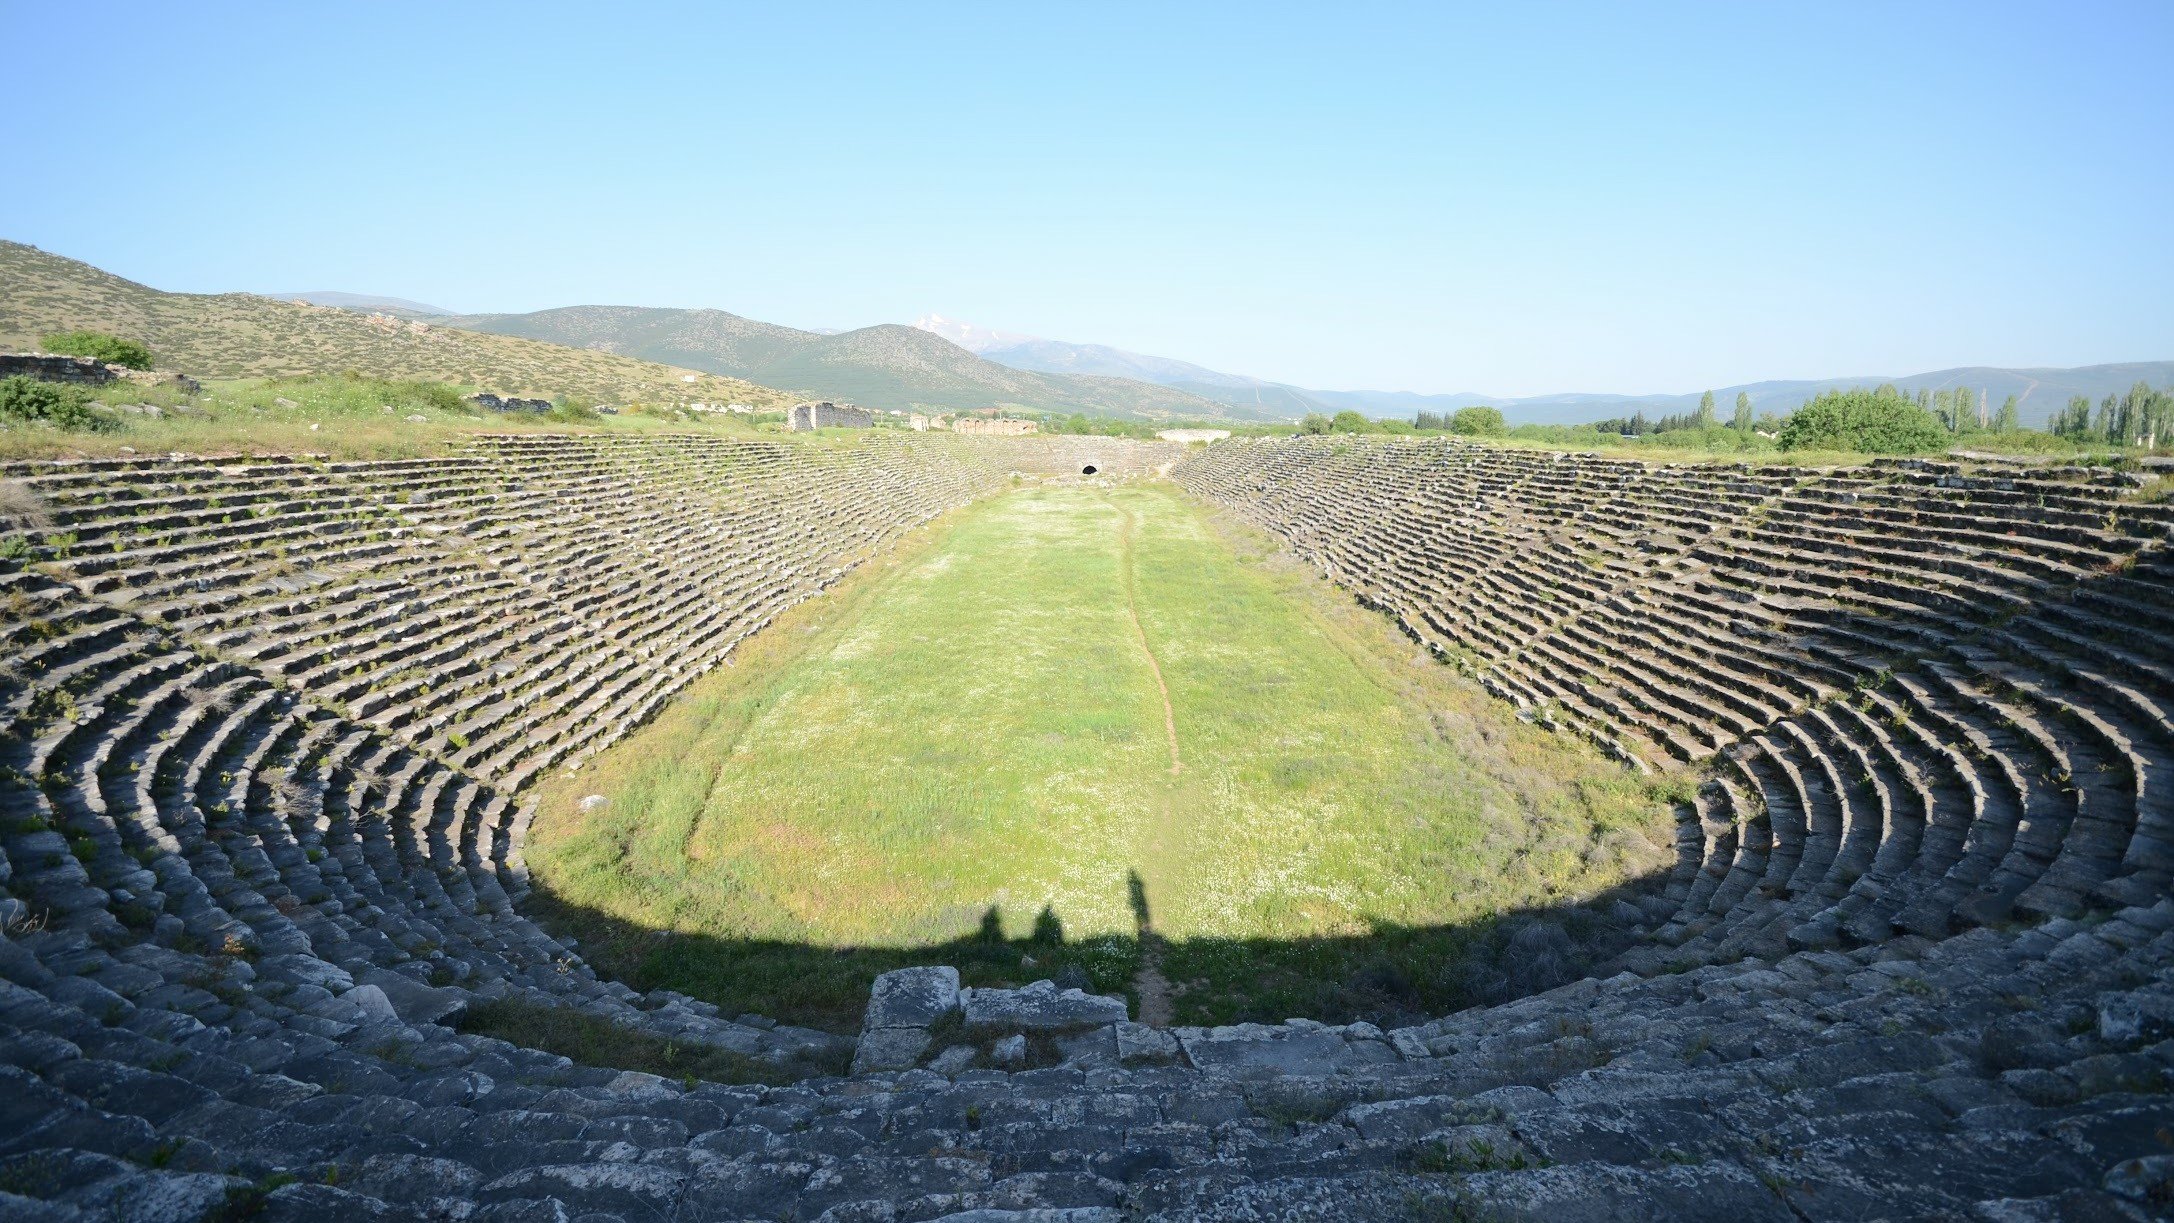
[0,430,2174,1223]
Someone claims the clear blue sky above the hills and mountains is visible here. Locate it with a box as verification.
[0,0,2174,393]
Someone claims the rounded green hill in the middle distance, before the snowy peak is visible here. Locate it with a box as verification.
[439,306,1239,419]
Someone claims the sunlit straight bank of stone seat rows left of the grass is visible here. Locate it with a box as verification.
[0,439,1008,890]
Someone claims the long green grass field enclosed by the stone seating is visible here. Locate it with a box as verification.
[528,484,1676,1030]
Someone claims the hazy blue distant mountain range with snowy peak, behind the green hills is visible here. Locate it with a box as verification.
[913,315,2174,424]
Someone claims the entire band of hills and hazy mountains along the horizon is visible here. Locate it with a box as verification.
[0,243,2174,424]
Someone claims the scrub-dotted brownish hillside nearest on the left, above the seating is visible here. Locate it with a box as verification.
[0,241,794,406]
